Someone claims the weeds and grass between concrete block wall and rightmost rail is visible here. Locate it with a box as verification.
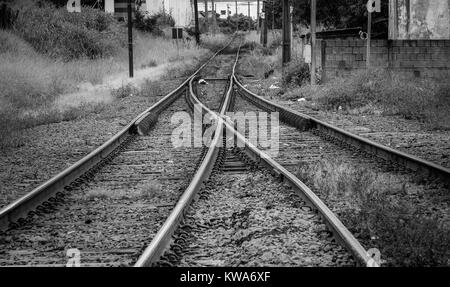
[295,69,450,129]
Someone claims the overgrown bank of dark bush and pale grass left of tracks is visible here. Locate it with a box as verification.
[0,1,207,148]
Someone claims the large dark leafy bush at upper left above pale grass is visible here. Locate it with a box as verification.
[15,5,127,61]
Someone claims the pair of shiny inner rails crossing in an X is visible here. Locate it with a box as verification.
[135,44,378,267]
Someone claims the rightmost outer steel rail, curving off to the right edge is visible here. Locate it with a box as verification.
[233,75,450,183]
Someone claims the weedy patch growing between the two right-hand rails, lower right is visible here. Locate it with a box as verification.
[298,160,450,266]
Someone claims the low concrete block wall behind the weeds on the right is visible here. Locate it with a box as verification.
[317,40,450,78]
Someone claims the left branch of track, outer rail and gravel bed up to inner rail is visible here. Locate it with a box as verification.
[0,37,243,266]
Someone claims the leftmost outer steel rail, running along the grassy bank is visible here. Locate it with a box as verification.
[0,40,234,231]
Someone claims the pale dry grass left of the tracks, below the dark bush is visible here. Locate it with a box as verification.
[0,30,208,148]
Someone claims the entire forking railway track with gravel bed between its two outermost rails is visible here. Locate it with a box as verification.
[0,35,449,267]
